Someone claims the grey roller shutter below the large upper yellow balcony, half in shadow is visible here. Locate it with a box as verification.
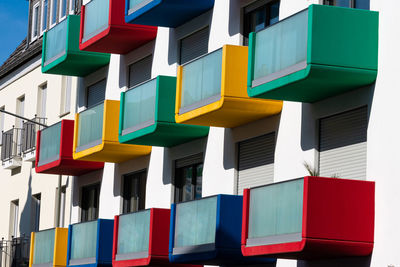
[237,133,275,195]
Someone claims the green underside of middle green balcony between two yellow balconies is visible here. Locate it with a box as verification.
[119,122,209,147]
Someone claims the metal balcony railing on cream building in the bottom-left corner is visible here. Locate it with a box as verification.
[0,236,30,267]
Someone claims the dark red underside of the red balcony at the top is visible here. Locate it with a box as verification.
[79,24,157,54]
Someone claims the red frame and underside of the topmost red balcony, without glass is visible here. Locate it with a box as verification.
[79,0,157,54]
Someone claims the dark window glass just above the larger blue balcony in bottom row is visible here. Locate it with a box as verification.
[175,163,203,203]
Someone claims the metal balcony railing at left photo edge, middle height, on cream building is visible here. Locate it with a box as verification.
[1,126,22,163]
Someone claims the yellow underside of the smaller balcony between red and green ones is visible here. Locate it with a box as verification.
[73,141,151,163]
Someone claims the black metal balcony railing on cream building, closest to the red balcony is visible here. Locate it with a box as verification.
[21,116,47,154]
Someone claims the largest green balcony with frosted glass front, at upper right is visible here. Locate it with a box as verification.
[247,5,379,102]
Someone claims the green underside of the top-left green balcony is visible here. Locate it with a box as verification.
[42,52,110,77]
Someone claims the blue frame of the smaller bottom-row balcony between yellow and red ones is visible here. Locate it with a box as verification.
[67,219,114,267]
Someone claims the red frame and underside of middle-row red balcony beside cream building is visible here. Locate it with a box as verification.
[35,120,104,176]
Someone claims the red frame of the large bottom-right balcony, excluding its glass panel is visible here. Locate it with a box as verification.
[242,176,375,259]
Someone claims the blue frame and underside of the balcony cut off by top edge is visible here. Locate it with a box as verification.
[125,0,215,28]
